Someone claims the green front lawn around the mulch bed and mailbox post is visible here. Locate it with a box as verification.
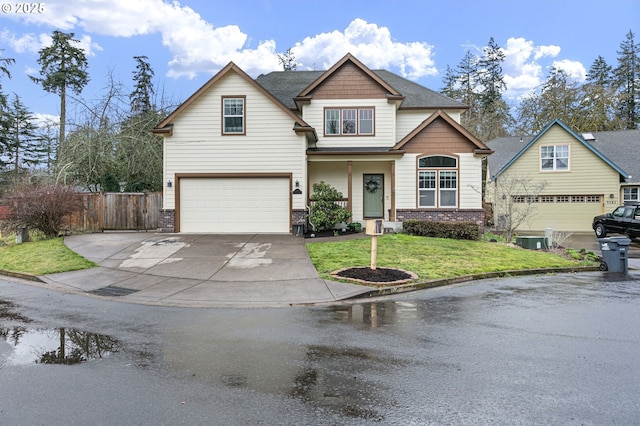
[307,234,596,281]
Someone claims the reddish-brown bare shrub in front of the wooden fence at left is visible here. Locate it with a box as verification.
[5,183,83,238]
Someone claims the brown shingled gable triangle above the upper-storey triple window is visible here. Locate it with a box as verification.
[312,62,387,99]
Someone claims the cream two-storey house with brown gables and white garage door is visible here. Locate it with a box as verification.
[153,55,492,233]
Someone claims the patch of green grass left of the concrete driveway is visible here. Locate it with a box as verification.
[0,238,96,275]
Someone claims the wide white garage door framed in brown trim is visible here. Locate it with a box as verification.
[180,177,291,233]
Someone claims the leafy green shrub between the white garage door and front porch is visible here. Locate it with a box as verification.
[309,182,351,231]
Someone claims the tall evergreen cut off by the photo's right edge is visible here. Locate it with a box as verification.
[614,31,640,129]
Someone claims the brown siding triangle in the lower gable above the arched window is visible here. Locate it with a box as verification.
[402,118,476,154]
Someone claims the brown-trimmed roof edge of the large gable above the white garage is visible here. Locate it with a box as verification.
[152,62,313,135]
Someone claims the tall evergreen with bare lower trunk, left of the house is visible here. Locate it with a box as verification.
[31,30,89,145]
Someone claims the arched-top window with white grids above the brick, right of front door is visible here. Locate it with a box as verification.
[418,155,458,207]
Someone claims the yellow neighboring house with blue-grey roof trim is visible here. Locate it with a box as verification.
[485,120,640,234]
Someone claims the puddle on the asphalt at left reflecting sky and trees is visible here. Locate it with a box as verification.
[0,326,120,365]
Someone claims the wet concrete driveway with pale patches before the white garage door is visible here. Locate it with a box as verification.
[40,232,371,307]
